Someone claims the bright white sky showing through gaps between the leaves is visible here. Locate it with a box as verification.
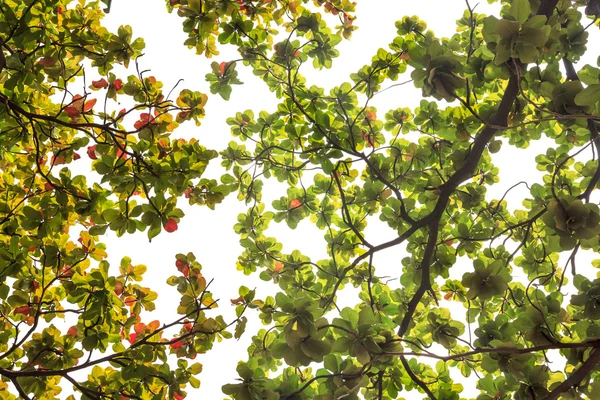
[49,0,598,399]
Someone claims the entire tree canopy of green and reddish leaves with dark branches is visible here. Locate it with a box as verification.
[0,0,600,400]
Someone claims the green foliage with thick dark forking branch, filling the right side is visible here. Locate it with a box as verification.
[200,0,600,399]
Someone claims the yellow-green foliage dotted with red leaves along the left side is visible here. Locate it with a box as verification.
[0,0,251,399]
